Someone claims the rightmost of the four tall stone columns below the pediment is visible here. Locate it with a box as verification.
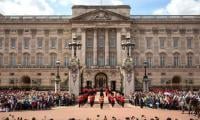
[116,29,122,66]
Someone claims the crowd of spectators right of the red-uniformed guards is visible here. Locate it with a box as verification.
[129,90,200,114]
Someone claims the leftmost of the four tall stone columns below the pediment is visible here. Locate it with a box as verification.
[80,29,86,65]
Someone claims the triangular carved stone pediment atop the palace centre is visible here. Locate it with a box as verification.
[71,9,130,21]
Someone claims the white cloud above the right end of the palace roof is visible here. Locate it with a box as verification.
[153,0,200,15]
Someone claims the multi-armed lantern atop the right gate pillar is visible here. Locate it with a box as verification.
[121,37,135,57]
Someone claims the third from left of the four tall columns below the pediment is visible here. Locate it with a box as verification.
[105,29,109,66]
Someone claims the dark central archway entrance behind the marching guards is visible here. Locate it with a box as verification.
[94,73,108,89]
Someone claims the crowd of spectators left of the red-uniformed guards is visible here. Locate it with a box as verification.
[0,90,75,112]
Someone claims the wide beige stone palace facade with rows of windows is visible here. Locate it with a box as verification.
[0,5,200,90]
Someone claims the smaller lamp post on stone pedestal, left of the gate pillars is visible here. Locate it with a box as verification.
[55,60,61,93]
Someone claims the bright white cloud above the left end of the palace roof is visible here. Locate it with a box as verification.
[0,0,54,15]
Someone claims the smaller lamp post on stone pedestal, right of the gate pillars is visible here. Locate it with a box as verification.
[143,60,149,92]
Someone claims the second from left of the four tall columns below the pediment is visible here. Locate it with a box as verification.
[93,29,97,65]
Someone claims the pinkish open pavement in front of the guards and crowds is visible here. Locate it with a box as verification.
[0,104,197,120]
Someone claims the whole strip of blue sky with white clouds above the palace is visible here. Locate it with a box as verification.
[0,0,200,15]
